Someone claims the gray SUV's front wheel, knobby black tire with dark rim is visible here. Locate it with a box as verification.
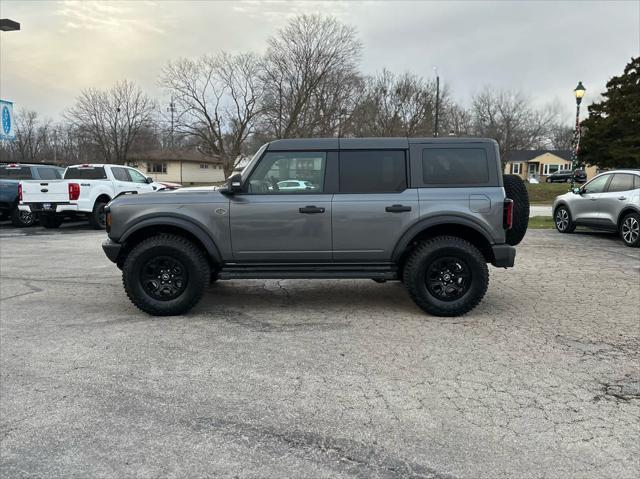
[122,234,211,316]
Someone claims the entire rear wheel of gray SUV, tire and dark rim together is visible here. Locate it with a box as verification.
[403,236,489,316]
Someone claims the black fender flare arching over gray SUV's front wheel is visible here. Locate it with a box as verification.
[118,216,222,266]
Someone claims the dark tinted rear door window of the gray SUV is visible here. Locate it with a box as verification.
[340,150,407,193]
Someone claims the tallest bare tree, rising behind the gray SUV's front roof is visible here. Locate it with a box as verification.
[262,15,362,138]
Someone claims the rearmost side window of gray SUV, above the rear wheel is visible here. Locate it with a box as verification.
[422,148,489,185]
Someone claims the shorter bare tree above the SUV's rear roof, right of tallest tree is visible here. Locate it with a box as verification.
[352,70,449,136]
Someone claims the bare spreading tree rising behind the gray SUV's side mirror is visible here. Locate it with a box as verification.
[160,52,263,176]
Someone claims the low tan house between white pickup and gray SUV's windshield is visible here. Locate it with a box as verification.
[127,149,225,186]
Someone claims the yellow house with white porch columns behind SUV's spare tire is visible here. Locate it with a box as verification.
[504,150,598,181]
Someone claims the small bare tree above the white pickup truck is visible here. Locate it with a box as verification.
[65,80,155,164]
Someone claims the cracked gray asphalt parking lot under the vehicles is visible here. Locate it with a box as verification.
[0,224,640,478]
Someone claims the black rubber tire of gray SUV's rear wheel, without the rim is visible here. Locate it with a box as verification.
[403,236,489,316]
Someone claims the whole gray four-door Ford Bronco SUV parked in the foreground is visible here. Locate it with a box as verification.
[103,138,529,316]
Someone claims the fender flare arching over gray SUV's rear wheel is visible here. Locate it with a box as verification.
[392,215,494,265]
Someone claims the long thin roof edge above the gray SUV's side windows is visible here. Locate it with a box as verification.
[268,137,495,150]
